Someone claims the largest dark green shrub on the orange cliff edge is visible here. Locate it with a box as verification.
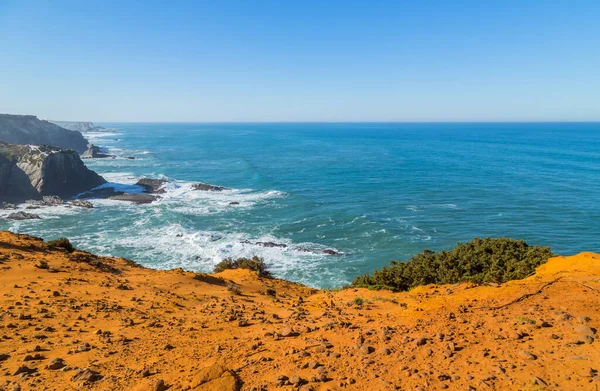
[352,238,555,291]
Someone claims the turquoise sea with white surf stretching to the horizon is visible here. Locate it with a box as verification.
[0,123,600,287]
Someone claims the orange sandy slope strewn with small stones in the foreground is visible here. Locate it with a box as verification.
[0,232,600,391]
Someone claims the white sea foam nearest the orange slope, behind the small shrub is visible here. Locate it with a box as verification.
[76,222,334,283]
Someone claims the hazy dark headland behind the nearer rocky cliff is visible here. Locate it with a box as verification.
[0,114,88,153]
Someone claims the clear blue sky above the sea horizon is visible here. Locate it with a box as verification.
[0,0,600,122]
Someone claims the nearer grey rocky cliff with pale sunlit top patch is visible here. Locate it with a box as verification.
[0,141,106,202]
